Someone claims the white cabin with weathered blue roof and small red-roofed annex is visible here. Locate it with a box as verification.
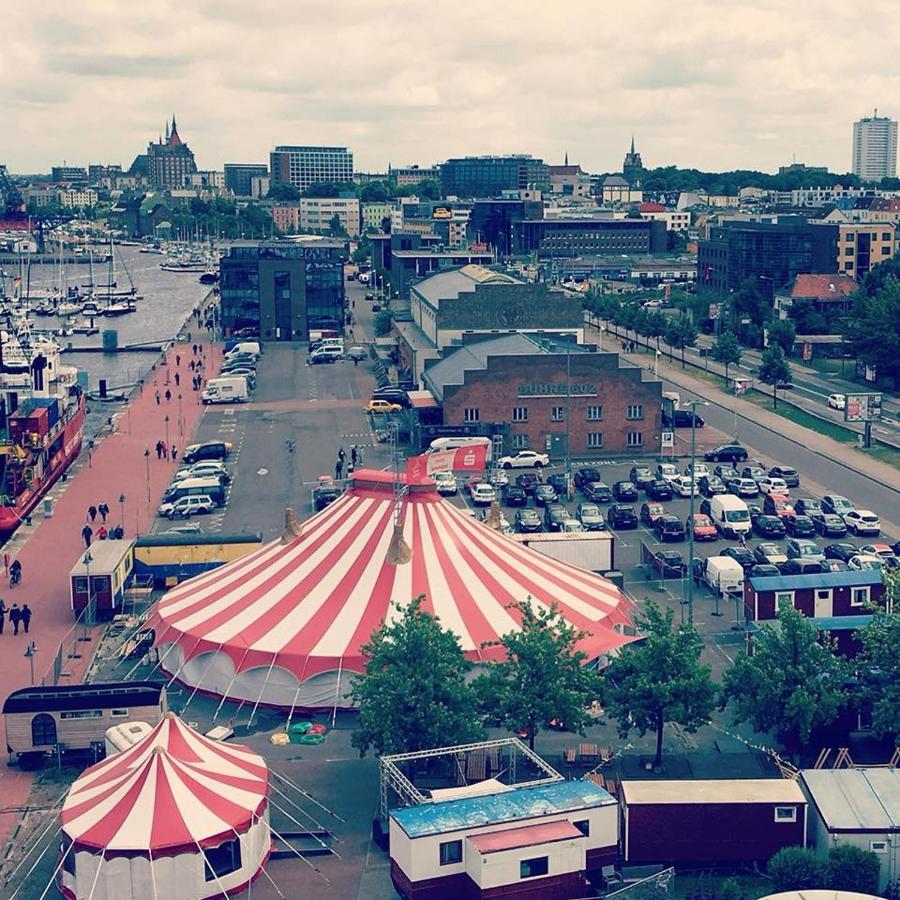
[389,781,618,900]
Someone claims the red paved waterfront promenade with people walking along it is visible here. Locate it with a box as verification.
[0,334,221,845]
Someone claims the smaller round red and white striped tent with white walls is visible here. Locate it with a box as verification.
[59,713,271,900]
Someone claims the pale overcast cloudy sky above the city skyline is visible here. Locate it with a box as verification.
[0,0,900,172]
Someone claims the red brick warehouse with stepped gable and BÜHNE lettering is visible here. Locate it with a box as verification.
[423,334,662,458]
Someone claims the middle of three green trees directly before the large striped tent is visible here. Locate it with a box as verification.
[476,599,600,750]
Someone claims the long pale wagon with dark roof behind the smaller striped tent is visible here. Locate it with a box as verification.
[3,681,166,768]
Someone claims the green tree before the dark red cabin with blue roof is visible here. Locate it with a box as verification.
[722,601,847,752]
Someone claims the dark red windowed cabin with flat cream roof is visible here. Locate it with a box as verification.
[619,778,806,866]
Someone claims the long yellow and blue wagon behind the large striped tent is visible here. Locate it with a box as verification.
[134,532,262,588]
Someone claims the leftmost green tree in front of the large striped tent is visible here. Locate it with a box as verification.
[350,595,484,756]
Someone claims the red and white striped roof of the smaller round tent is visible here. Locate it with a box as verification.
[61,713,269,856]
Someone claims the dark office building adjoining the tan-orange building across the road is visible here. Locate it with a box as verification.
[697,217,838,299]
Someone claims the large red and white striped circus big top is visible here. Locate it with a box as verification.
[148,470,632,708]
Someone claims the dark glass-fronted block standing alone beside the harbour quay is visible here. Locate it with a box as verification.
[219,241,345,341]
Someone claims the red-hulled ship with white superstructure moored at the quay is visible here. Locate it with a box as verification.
[0,331,85,540]
